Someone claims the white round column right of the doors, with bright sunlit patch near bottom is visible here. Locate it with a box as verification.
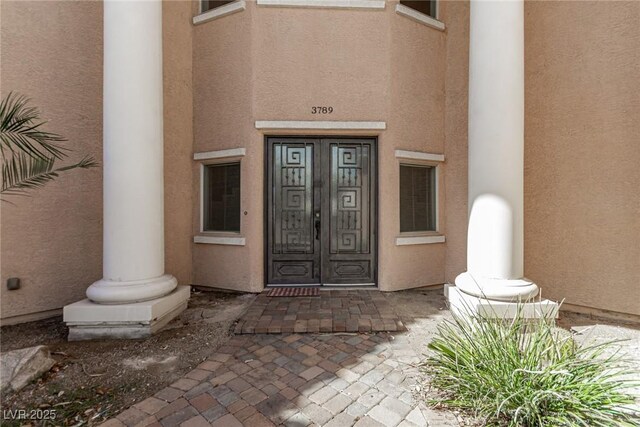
[456,0,538,301]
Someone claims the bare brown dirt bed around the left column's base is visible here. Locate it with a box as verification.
[0,292,255,426]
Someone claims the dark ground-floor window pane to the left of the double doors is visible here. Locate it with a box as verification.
[203,163,240,232]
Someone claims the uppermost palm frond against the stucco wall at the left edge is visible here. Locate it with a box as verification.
[0,92,67,160]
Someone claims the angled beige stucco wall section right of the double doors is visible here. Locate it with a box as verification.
[378,2,446,290]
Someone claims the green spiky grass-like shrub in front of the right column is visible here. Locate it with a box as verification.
[423,310,640,427]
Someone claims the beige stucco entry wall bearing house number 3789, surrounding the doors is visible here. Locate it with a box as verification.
[193,2,464,291]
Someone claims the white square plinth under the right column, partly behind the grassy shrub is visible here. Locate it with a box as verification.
[444,284,560,319]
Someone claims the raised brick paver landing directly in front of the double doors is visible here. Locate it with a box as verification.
[235,290,405,334]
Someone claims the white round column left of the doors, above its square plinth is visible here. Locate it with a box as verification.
[87,0,177,304]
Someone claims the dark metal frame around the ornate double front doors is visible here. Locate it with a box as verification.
[262,134,380,288]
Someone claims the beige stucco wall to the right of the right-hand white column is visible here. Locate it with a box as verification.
[525,1,640,314]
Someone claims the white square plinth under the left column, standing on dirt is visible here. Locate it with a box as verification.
[63,286,191,341]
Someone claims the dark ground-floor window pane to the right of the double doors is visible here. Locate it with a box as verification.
[400,165,436,232]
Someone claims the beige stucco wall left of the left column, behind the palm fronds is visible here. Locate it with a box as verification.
[0,1,102,323]
